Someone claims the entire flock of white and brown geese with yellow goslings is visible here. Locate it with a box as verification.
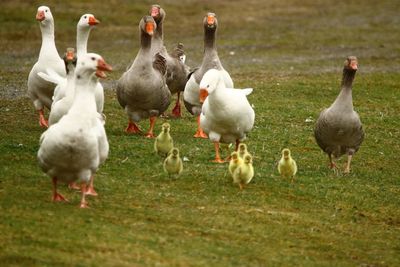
[28,5,364,208]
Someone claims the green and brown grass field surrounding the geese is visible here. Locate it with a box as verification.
[0,0,400,266]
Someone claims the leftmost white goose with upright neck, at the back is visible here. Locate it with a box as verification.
[28,6,66,127]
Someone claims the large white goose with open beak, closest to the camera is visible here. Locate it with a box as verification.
[38,53,111,208]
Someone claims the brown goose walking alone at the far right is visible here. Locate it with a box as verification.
[314,57,364,173]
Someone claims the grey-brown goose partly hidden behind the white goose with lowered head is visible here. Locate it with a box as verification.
[183,13,233,138]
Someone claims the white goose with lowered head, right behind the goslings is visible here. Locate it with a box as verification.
[199,69,255,163]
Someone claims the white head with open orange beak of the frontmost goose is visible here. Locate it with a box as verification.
[75,53,112,79]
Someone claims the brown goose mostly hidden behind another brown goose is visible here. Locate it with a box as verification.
[150,5,189,117]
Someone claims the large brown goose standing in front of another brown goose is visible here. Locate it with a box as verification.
[117,16,171,137]
